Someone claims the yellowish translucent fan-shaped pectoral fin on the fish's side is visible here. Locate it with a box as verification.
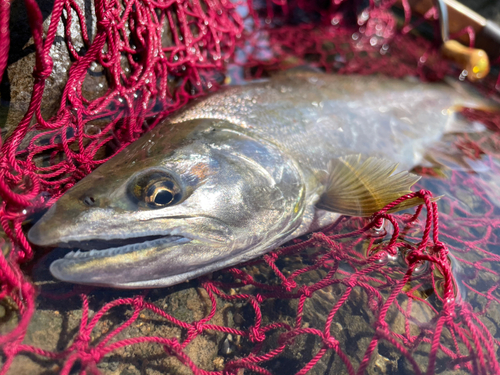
[316,155,424,216]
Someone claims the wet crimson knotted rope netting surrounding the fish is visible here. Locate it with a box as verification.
[0,0,500,374]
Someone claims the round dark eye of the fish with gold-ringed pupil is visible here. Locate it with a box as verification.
[132,172,182,208]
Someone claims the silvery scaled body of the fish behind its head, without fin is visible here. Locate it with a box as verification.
[171,72,464,173]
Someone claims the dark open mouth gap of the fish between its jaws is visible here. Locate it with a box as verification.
[56,235,191,262]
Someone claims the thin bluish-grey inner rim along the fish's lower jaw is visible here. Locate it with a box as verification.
[63,236,191,260]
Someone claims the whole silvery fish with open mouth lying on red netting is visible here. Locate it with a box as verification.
[28,71,484,289]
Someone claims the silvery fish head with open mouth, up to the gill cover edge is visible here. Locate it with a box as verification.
[28,120,304,288]
